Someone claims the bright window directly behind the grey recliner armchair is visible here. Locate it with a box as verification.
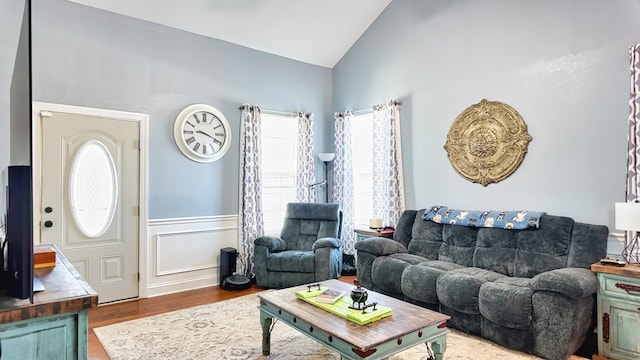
[261,113,298,234]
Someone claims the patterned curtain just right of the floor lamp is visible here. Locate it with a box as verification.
[332,111,356,255]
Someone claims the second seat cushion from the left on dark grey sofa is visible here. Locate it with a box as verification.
[401,260,463,304]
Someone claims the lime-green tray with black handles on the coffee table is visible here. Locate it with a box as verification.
[296,287,391,325]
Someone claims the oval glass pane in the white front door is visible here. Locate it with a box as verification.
[69,140,118,238]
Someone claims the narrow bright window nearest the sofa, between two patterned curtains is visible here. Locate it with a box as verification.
[351,113,373,228]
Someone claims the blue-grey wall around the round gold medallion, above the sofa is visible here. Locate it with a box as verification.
[333,0,640,230]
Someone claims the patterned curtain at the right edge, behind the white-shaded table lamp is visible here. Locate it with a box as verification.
[625,44,640,259]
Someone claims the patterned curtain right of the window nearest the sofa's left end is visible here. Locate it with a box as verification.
[373,101,405,227]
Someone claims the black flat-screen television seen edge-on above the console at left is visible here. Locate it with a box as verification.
[0,0,33,302]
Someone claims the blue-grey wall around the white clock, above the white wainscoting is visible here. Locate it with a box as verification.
[32,0,332,219]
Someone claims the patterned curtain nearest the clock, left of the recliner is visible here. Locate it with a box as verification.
[238,104,264,278]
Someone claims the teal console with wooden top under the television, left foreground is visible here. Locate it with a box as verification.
[0,245,98,360]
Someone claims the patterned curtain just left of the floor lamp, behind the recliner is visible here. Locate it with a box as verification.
[296,113,318,202]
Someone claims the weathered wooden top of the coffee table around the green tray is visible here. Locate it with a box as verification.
[258,280,449,349]
